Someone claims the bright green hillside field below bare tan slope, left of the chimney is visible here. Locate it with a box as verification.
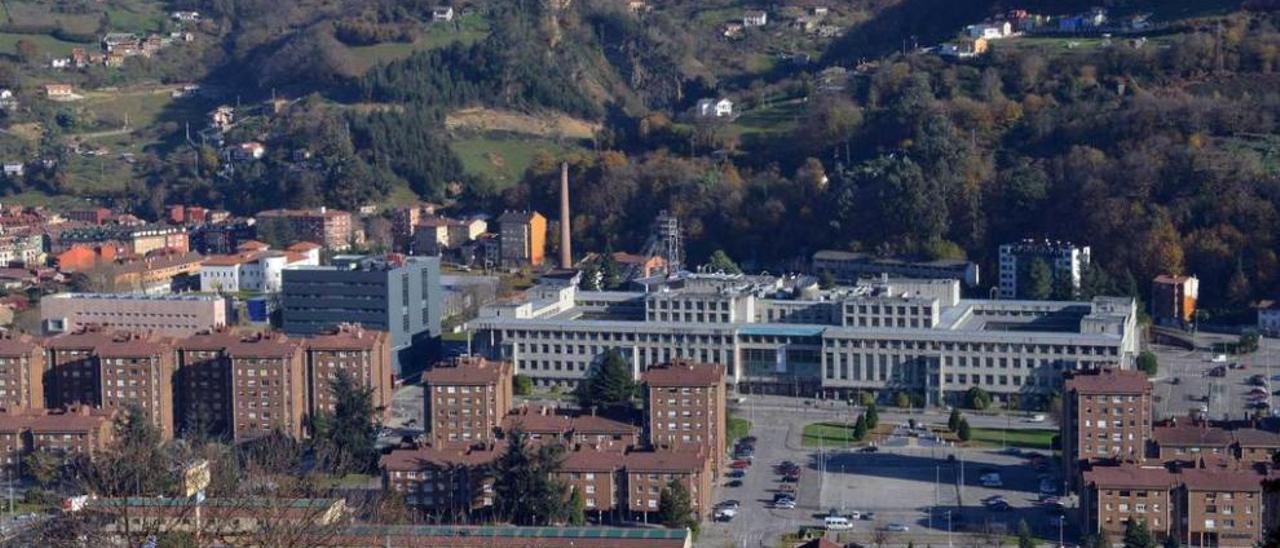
[449,137,576,188]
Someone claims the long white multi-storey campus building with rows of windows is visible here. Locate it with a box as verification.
[468,274,1138,403]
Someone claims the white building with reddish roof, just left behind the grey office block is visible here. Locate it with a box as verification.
[200,248,320,293]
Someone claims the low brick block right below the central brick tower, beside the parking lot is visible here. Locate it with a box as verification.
[623,451,714,519]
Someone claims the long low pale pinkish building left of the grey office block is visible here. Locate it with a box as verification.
[40,293,227,337]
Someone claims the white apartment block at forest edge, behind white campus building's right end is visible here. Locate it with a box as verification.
[1000,239,1089,298]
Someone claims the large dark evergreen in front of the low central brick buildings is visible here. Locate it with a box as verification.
[493,428,568,525]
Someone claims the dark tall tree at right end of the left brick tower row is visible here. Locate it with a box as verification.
[317,370,378,474]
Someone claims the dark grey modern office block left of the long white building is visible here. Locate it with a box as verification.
[280,255,442,376]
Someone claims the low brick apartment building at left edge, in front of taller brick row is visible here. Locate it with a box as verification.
[0,406,115,472]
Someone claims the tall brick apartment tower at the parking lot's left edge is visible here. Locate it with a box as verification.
[643,360,728,476]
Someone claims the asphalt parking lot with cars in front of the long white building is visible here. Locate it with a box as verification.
[699,402,1076,547]
